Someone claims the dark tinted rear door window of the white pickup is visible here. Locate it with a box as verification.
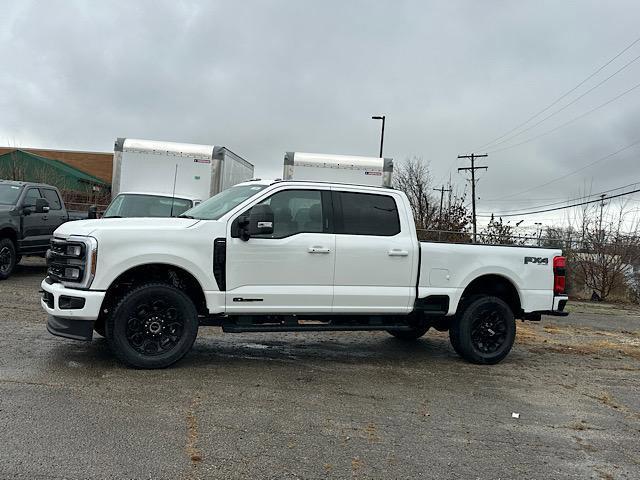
[334,192,400,237]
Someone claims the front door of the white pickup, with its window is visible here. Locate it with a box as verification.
[225,187,335,313]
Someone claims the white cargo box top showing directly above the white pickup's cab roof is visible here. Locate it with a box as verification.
[283,152,393,187]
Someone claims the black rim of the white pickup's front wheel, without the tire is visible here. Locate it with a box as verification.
[125,298,184,356]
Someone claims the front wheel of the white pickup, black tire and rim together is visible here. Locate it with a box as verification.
[105,283,198,369]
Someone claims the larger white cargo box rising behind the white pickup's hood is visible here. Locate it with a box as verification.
[111,138,253,204]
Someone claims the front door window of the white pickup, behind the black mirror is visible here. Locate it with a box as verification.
[257,190,324,238]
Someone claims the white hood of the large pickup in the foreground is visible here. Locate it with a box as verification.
[54,218,200,238]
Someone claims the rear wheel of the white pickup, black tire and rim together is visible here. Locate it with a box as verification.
[449,296,516,365]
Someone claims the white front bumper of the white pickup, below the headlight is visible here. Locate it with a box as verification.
[40,279,106,322]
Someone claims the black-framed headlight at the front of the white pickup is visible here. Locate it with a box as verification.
[47,236,98,289]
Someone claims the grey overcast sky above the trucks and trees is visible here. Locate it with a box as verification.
[0,0,640,228]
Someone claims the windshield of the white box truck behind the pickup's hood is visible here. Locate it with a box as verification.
[102,193,192,218]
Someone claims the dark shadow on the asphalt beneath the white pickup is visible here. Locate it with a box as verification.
[45,334,522,376]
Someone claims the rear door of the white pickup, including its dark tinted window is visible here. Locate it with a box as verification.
[332,188,418,313]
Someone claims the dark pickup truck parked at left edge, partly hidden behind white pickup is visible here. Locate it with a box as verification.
[0,180,95,280]
